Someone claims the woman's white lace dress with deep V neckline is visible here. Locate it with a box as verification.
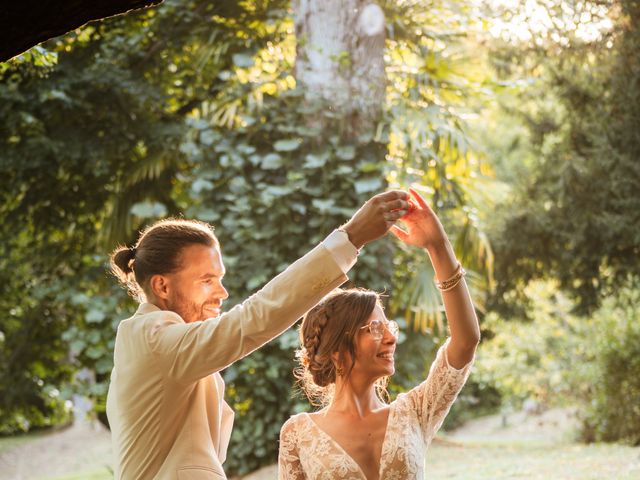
[278,340,473,480]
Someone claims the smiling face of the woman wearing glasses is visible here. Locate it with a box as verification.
[351,304,397,382]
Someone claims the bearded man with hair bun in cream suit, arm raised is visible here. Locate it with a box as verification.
[107,191,409,480]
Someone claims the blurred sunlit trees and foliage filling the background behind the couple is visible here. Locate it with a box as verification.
[0,0,640,474]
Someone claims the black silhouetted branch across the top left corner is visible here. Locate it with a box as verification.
[0,0,162,62]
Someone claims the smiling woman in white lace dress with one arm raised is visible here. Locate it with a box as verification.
[278,189,480,480]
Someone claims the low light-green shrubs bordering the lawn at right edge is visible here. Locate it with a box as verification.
[475,280,640,445]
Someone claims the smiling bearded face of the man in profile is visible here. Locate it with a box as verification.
[166,245,229,323]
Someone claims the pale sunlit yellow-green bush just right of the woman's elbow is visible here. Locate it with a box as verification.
[474,282,587,407]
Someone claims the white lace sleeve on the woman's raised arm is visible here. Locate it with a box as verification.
[406,339,473,445]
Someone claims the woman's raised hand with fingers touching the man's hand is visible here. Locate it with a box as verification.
[391,188,448,250]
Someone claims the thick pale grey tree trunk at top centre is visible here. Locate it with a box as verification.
[294,0,386,134]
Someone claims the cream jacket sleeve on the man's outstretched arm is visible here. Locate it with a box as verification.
[146,244,348,383]
